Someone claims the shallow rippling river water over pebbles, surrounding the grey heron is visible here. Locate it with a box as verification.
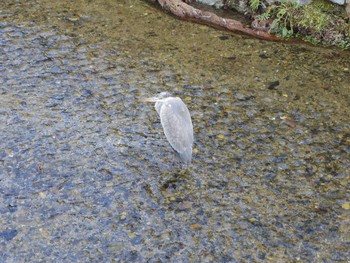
[0,0,350,262]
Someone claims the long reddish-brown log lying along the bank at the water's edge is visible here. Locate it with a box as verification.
[157,0,279,41]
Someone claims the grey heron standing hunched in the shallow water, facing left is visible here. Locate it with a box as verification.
[141,92,193,164]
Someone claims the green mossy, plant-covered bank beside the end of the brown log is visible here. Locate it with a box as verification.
[252,0,350,49]
